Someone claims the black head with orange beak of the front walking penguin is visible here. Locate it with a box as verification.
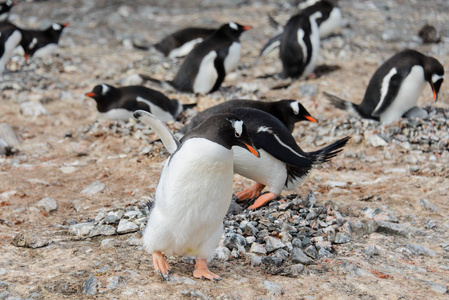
[181,113,260,157]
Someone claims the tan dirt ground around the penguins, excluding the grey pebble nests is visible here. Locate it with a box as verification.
[0,0,449,299]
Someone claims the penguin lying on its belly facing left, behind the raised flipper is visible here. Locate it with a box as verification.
[85,83,196,122]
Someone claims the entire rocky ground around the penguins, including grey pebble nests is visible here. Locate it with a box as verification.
[0,0,449,299]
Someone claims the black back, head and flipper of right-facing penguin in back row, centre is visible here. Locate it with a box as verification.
[171,23,244,93]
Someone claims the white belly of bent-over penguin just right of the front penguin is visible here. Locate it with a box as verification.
[232,147,287,195]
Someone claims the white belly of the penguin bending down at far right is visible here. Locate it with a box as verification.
[380,66,426,123]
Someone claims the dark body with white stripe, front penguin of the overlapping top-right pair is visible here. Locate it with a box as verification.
[279,11,322,79]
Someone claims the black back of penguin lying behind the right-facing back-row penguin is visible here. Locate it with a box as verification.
[154,27,217,56]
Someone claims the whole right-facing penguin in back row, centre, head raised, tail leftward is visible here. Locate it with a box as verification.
[140,22,252,94]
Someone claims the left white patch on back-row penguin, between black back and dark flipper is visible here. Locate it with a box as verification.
[193,51,218,93]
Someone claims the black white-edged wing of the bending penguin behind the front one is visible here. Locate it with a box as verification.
[253,127,312,168]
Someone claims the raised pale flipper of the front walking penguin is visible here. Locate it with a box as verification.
[133,110,180,154]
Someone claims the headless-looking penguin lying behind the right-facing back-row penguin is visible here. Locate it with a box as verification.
[154,27,217,58]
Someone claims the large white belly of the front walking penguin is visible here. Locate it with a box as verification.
[143,138,233,258]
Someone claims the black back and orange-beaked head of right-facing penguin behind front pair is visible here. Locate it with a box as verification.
[179,99,317,133]
